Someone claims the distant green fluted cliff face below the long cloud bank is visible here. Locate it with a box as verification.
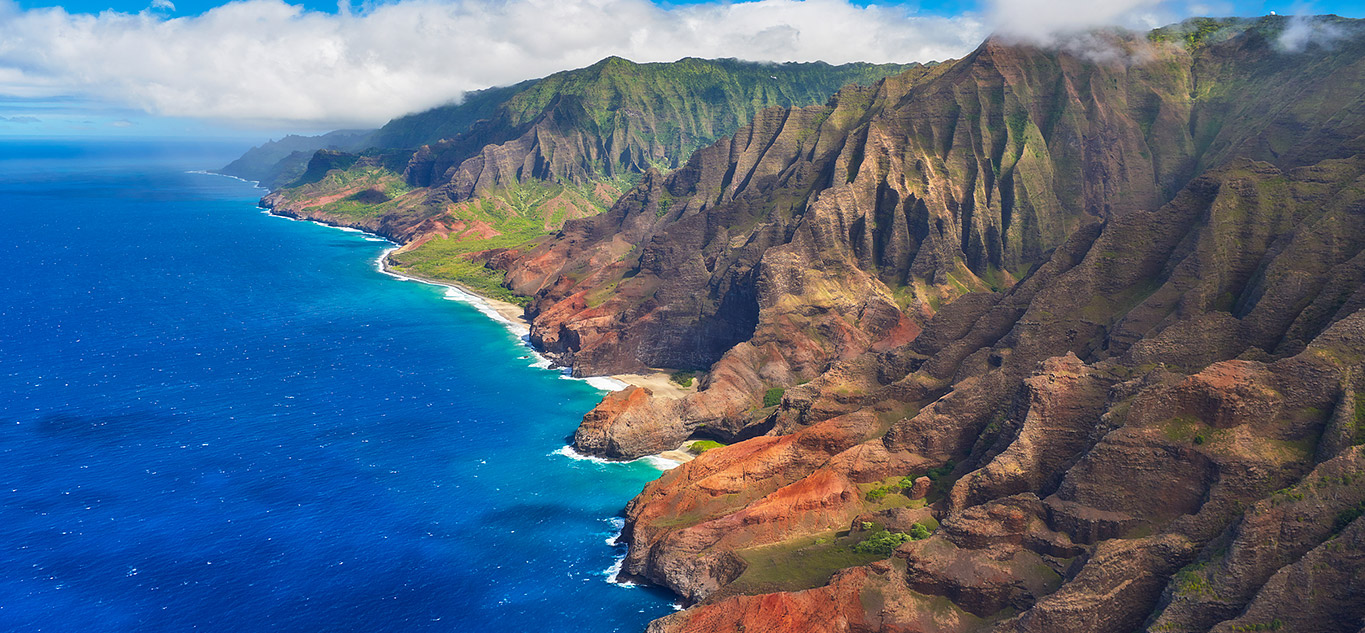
[398,57,924,195]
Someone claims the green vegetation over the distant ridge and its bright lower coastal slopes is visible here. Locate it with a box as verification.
[251,57,925,309]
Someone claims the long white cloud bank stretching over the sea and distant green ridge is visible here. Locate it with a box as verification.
[0,0,988,127]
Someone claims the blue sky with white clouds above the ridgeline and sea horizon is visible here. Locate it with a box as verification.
[0,0,1365,139]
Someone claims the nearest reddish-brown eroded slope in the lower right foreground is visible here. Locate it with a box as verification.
[625,153,1365,630]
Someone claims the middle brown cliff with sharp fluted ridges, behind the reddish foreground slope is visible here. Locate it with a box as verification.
[508,22,1362,457]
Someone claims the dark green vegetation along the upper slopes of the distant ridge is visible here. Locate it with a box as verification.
[371,57,927,167]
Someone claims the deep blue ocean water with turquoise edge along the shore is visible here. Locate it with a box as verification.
[0,141,670,633]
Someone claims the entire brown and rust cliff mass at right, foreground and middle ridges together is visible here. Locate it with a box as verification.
[483,18,1365,632]
